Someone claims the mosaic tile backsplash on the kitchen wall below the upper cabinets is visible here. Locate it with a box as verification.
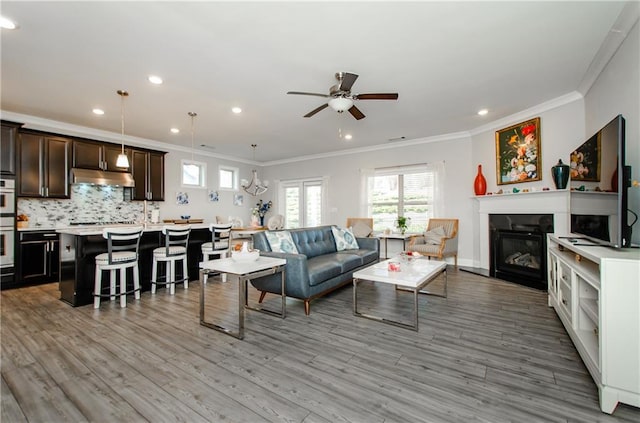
[18,185,157,227]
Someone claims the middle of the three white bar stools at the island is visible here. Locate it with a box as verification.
[151,225,191,295]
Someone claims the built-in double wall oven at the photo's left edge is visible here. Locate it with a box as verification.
[0,179,16,288]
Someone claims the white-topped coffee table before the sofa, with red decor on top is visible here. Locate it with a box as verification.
[353,258,447,331]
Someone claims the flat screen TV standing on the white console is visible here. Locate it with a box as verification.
[570,115,631,248]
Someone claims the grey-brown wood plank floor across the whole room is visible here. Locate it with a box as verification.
[0,271,640,423]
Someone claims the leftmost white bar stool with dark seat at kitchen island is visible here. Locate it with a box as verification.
[93,226,143,308]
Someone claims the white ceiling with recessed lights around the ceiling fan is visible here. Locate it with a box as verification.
[1,0,626,162]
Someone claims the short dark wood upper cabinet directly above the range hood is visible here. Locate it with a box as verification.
[73,140,131,172]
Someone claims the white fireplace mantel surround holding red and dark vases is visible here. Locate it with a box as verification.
[474,189,571,269]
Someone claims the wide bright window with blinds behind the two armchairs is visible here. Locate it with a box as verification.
[363,164,443,232]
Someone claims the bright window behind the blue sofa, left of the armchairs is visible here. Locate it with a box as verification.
[278,178,326,229]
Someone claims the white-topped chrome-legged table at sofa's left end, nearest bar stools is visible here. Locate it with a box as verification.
[200,256,287,339]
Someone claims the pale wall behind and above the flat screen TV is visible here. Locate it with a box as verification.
[585,21,640,244]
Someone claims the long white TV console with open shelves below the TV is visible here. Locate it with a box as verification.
[547,234,640,414]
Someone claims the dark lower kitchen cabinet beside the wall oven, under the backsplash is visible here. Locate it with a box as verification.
[17,231,60,285]
